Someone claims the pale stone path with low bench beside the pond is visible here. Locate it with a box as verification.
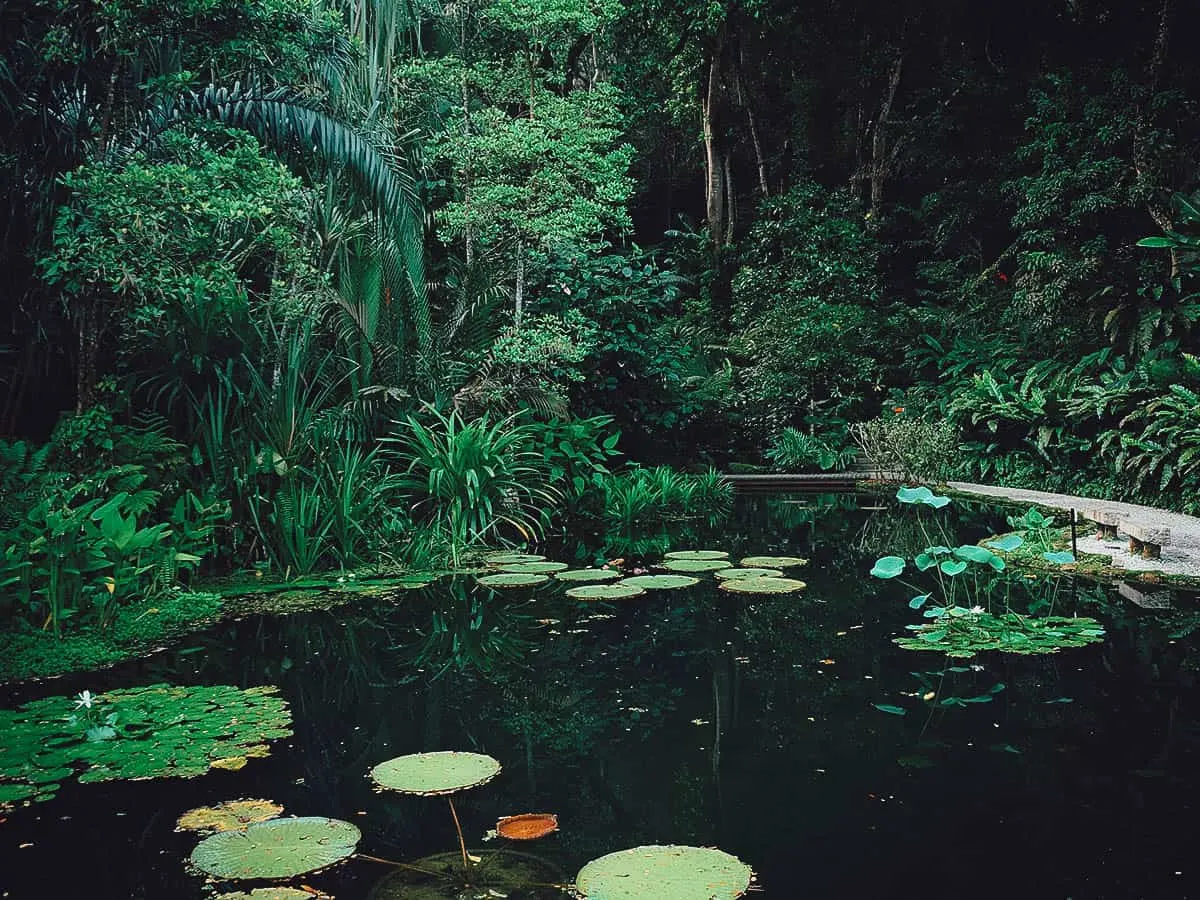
[949,481,1200,577]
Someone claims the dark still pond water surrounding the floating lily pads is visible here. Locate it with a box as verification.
[0,497,1200,900]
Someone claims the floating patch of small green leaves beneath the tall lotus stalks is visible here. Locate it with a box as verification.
[895,607,1104,658]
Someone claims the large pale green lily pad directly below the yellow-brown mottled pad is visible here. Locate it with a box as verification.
[191,816,362,878]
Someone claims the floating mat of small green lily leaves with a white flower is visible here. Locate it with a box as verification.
[0,684,292,804]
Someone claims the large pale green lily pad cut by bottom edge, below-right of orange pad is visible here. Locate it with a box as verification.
[575,846,754,900]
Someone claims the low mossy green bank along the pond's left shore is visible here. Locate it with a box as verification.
[0,572,452,684]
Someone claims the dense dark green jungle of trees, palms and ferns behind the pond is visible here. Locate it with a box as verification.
[0,0,1200,600]
